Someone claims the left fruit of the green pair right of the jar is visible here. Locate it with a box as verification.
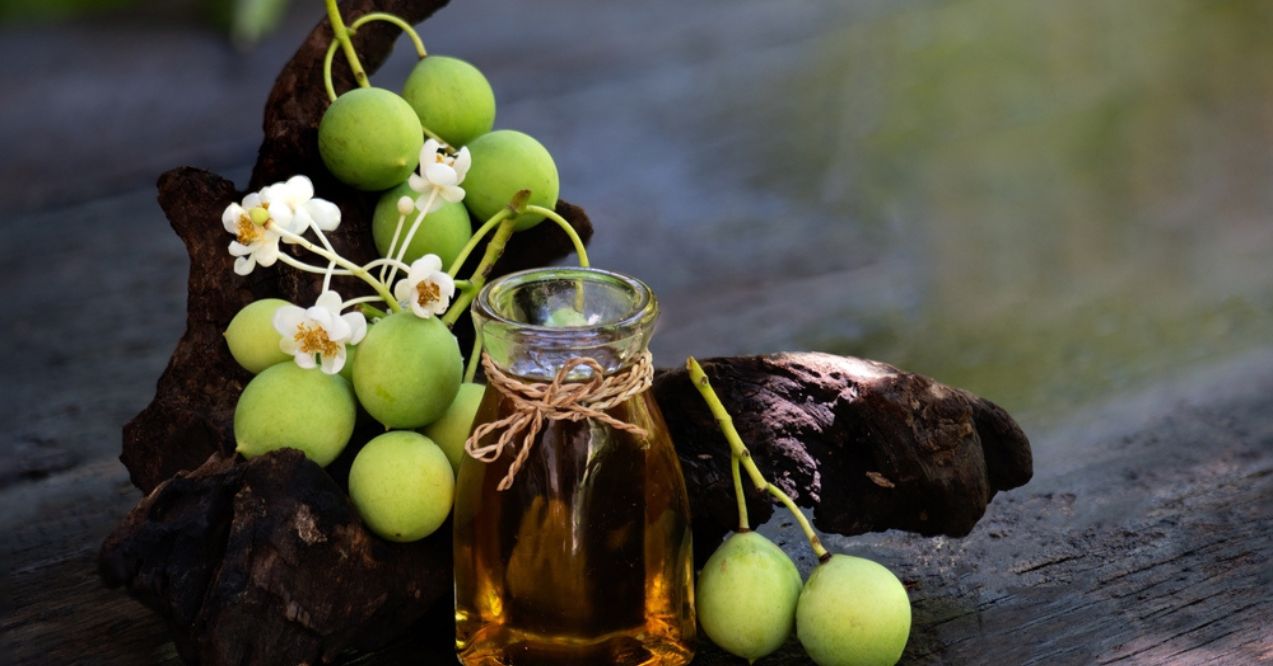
[695,532,801,661]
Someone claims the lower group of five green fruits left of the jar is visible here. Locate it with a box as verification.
[225,298,485,541]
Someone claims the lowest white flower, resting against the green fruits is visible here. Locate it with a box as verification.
[274,289,367,374]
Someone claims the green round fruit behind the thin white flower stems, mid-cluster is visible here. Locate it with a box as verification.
[372,183,474,267]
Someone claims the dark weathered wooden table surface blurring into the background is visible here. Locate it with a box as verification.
[0,0,1273,663]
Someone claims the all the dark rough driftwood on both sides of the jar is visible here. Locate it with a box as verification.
[99,0,1031,663]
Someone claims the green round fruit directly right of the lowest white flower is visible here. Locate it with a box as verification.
[354,312,463,429]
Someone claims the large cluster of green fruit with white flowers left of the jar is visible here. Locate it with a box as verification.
[225,1,575,541]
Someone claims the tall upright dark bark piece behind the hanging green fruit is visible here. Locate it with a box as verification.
[120,0,592,492]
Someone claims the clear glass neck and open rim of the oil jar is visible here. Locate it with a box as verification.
[472,267,658,382]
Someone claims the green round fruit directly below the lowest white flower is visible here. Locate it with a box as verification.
[234,363,358,466]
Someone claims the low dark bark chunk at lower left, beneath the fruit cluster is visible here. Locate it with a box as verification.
[99,450,451,665]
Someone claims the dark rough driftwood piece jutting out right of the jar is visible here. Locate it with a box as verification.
[653,353,1032,562]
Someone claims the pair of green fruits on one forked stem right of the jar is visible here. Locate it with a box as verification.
[686,358,910,666]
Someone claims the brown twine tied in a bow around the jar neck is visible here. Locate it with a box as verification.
[465,351,654,490]
